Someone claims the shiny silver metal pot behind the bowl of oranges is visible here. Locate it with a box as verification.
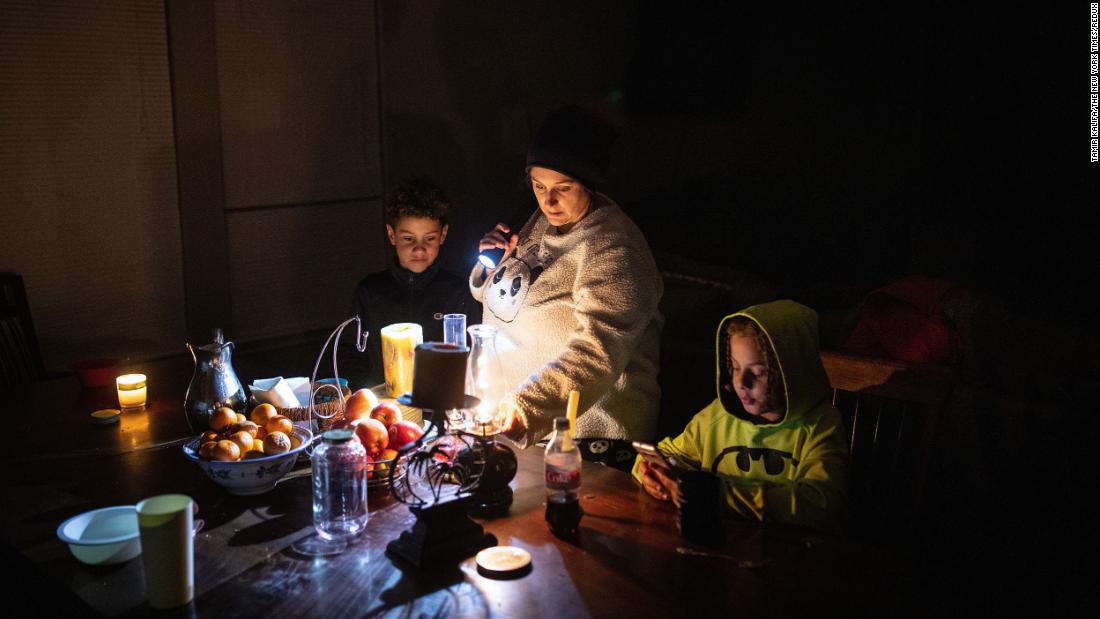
[184,329,249,434]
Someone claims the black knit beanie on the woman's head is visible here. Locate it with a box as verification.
[527,106,616,191]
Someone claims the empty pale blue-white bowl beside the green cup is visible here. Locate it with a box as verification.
[57,505,141,565]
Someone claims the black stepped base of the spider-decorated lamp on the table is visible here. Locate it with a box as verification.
[386,497,496,567]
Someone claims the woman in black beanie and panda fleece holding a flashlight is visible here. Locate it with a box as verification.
[470,107,663,469]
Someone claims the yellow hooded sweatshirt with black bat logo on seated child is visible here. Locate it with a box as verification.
[634,300,848,533]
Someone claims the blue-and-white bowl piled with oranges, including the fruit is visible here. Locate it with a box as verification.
[184,404,314,495]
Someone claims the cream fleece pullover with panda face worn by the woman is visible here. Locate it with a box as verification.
[470,199,663,444]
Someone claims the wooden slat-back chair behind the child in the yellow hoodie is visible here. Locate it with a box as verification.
[822,351,956,544]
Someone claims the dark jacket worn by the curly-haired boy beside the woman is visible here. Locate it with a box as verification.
[339,262,482,389]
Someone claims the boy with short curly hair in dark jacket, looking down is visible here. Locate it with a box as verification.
[340,180,481,390]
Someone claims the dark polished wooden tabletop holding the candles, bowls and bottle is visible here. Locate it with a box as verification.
[0,360,930,618]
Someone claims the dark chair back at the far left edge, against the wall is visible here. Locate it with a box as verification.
[0,273,45,388]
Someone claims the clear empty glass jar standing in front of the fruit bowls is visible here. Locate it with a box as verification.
[310,429,367,541]
